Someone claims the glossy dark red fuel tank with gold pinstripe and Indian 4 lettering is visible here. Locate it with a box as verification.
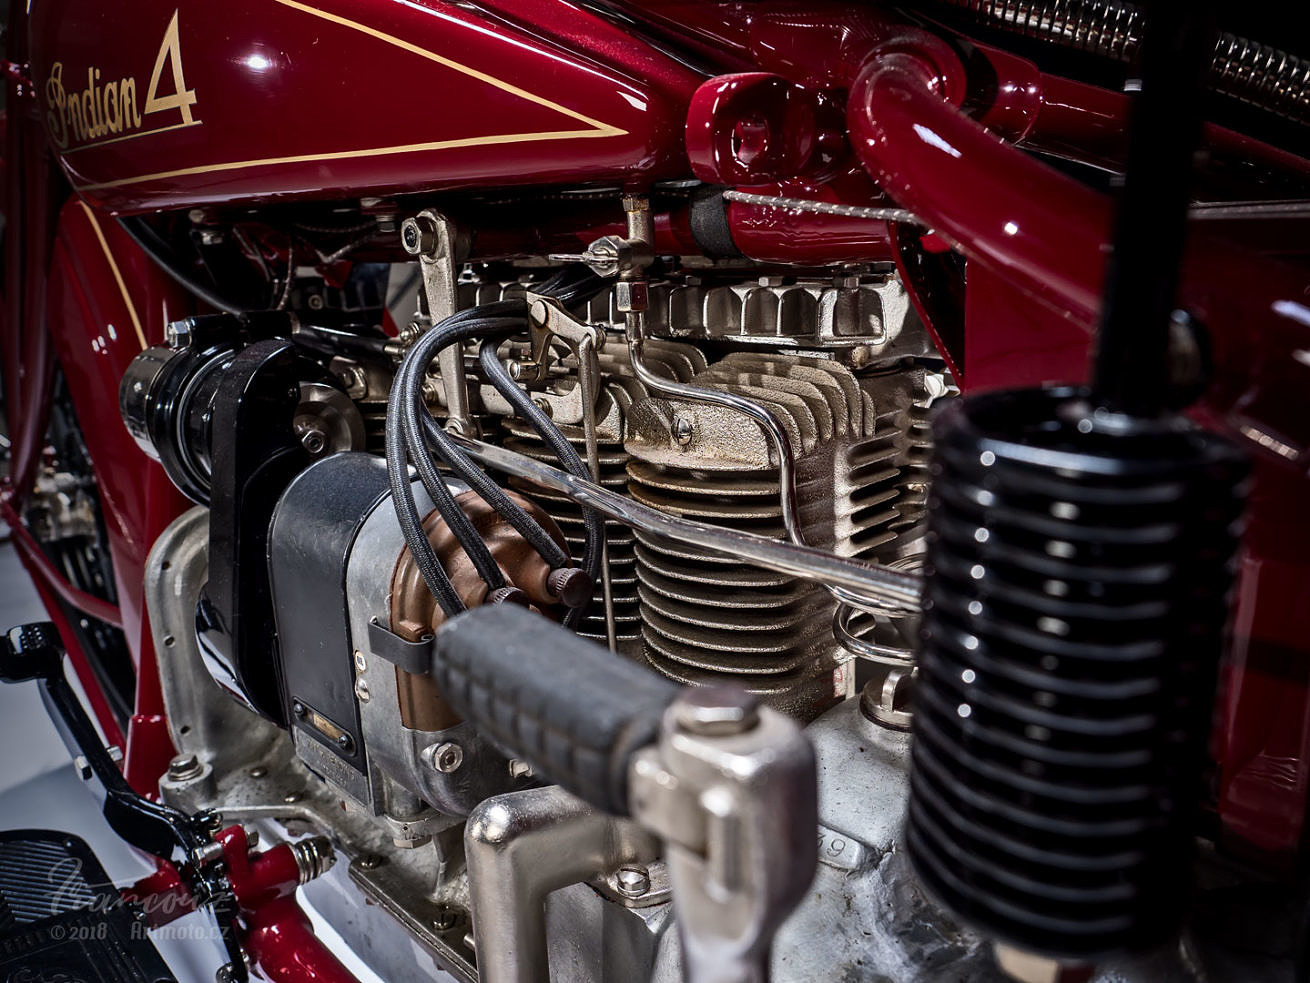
[30,0,702,212]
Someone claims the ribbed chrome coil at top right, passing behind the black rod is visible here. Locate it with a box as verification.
[929,0,1310,123]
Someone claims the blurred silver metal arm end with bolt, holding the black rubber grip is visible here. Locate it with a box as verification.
[629,687,819,983]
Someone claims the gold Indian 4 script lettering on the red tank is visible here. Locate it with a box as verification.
[46,10,200,151]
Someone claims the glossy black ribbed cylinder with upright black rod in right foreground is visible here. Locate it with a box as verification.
[907,4,1247,961]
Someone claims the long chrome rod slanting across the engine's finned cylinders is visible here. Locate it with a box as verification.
[452,436,924,612]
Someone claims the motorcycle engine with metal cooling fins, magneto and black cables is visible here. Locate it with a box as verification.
[121,193,1241,983]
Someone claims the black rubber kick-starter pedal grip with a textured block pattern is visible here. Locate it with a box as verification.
[432,604,679,815]
